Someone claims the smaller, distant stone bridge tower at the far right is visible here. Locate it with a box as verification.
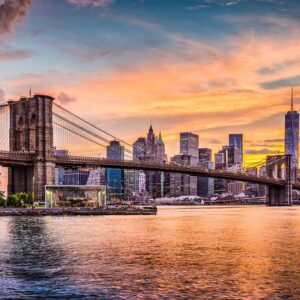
[266,154,293,206]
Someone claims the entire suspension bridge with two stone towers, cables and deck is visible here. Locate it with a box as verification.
[0,94,300,206]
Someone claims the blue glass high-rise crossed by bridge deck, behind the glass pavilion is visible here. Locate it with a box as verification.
[106,141,124,199]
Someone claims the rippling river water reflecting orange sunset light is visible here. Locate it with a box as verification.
[0,206,300,299]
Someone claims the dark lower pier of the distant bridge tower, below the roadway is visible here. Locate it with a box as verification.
[267,184,292,206]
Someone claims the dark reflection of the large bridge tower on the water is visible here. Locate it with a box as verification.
[6,217,81,298]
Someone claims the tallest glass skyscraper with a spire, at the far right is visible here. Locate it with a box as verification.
[285,87,299,169]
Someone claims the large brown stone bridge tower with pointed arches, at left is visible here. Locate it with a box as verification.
[8,95,55,202]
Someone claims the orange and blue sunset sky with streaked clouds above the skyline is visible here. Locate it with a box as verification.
[0,0,300,162]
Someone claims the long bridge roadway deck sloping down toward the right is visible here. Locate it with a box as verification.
[0,151,300,190]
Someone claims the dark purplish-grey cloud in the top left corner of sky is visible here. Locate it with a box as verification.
[0,0,32,34]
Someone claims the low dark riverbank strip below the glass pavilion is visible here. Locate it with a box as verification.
[0,206,157,217]
